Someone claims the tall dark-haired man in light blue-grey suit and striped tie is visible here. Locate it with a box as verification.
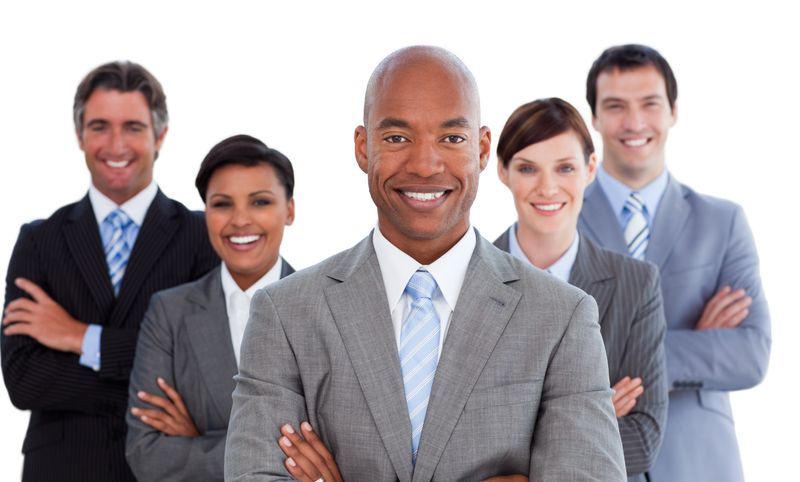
[579,45,770,482]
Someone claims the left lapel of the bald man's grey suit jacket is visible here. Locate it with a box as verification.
[325,236,411,482]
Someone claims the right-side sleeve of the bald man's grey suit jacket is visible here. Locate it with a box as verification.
[529,296,626,481]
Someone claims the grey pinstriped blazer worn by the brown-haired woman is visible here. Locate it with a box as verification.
[494,230,667,481]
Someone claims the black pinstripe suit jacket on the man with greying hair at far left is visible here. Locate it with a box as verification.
[2,190,219,482]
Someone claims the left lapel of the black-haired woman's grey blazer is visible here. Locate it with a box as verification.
[186,268,237,420]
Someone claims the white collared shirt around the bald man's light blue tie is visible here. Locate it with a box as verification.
[372,226,477,357]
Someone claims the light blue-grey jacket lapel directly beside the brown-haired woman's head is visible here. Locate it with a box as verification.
[579,182,628,254]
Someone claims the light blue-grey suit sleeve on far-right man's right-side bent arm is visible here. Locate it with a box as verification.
[666,206,771,391]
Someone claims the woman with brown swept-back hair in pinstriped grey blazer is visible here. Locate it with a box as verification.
[494,98,667,480]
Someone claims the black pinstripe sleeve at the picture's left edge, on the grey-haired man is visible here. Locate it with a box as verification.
[0,224,125,414]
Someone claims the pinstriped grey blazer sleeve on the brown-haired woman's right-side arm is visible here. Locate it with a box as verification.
[611,265,668,476]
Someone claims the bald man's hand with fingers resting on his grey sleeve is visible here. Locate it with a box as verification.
[278,422,342,482]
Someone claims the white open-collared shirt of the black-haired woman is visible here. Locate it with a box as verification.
[220,256,283,365]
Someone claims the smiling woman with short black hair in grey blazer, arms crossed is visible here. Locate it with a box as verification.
[126,135,294,482]
